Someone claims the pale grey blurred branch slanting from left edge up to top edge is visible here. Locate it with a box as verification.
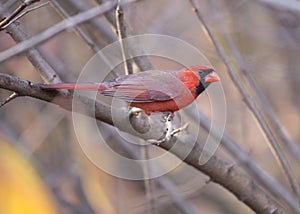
[0,0,137,63]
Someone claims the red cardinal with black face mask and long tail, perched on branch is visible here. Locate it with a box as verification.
[40,65,220,115]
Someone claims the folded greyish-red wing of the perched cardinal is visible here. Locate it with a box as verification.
[101,71,182,102]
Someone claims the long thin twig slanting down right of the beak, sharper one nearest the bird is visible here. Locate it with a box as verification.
[190,0,300,201]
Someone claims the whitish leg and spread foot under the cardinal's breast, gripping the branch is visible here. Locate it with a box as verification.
[147,112,188,145]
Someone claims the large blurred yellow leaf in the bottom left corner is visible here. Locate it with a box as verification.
[0,137,58,214]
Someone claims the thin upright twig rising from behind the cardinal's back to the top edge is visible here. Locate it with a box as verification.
[116,0,133,74]
